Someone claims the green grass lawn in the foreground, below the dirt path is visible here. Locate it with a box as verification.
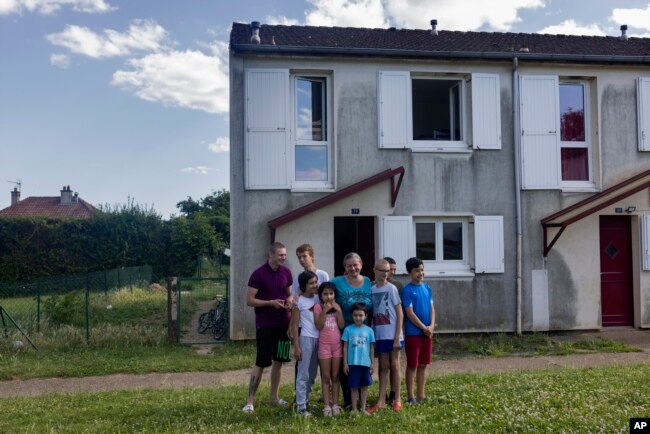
[0,365,650,433]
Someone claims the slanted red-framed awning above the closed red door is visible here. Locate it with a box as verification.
[541,170,650,257]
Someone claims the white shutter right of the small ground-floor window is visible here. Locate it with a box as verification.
[474,216,505,274]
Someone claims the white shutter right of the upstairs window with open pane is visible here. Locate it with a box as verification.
[472,74,501,149]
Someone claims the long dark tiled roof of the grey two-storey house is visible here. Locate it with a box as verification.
[230,23,650,63]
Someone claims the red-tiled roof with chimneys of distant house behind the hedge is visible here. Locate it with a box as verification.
[0,185,99,219]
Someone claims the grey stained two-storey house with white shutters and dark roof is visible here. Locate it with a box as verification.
[230,21,650,339]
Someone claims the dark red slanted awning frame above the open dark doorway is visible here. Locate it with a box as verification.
[267,166,404,240]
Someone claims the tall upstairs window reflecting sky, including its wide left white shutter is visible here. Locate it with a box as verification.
[244,69,334,191]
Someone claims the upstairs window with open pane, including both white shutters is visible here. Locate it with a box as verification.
[378,71,501,152]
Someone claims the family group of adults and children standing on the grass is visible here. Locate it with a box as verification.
[243,242,435,417]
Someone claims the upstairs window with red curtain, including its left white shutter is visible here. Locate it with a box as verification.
[520,75,594,190]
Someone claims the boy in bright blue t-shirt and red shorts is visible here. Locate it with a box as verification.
[402,258,436,404]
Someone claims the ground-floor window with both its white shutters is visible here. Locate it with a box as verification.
[378,216,504,277]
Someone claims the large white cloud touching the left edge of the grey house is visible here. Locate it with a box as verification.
[111,42,229,114]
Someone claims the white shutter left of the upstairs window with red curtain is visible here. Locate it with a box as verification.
[519,75,561,189]
